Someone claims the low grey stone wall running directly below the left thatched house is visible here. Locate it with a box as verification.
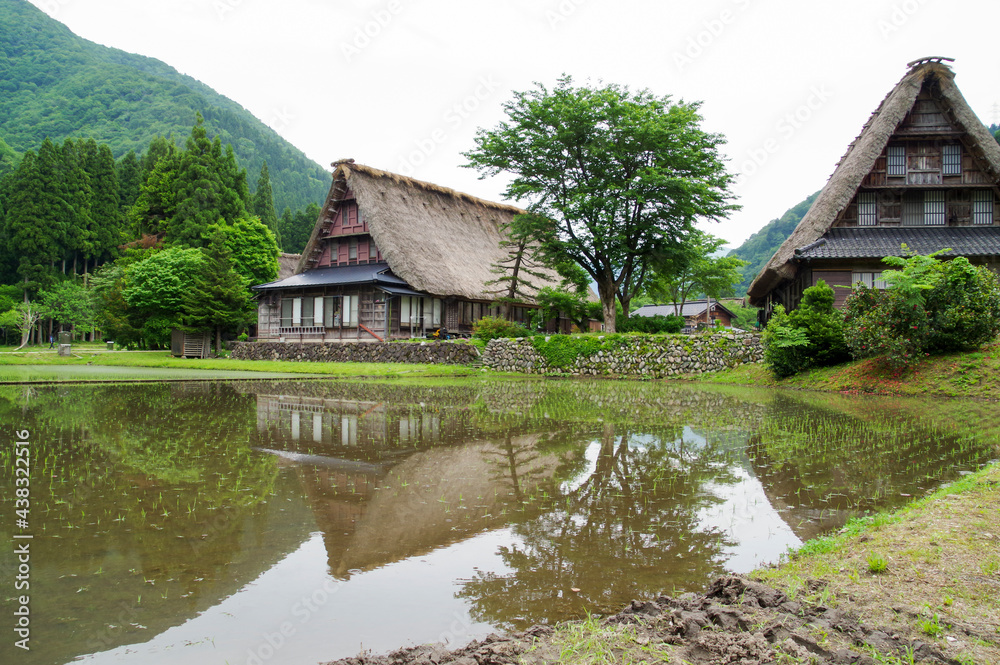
[232,342,479,365]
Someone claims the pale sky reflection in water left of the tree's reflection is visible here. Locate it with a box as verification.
[80,529,515,665]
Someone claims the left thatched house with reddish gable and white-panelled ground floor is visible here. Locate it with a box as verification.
[254,160,568,342]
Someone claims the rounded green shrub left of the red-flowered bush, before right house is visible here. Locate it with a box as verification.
[762,280,850,377]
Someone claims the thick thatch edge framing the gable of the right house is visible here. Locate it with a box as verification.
[747,58,1000,307]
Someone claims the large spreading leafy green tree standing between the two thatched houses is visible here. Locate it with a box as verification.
[465,76,737,332]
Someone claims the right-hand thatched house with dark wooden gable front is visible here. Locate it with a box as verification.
[747,57,1000,312]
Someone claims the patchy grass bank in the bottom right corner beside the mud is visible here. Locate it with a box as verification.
[754,465,1000,663]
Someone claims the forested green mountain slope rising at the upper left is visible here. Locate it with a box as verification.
[0,0,330,211]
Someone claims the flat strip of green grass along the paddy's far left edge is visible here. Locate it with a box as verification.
[0,347,476,382]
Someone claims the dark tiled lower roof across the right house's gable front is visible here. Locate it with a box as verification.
[795,226,1000,259]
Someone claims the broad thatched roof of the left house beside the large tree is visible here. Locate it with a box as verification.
[297,160,558,300]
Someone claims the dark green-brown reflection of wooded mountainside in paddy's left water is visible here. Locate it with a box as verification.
[0,383,298,662]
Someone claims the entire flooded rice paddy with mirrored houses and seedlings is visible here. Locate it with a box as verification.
[0,381,1000,665]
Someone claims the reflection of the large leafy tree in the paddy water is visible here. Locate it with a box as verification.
[457,423,748,628]
